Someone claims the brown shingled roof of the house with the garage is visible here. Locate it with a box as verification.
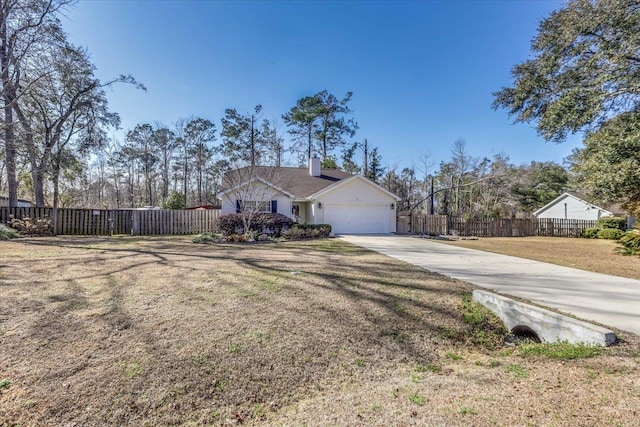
[222,166,354,199]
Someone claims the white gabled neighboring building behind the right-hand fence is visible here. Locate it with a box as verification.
[533,192,625,220]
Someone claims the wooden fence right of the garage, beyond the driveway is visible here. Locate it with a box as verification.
[397,214,596,237]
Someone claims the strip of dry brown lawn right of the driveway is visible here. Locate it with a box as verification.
[442,237,640,279]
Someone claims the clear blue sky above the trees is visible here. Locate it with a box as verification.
[63,0,580,172]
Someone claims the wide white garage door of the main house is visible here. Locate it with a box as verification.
[324,204,395,234]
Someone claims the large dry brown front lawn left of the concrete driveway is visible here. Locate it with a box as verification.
[0,237,640,426]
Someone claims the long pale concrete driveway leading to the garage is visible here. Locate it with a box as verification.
[341,235,640,335]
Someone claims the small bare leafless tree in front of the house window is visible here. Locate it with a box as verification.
[223,166,282,234]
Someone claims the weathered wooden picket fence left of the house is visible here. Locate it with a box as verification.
[0,207,220,236]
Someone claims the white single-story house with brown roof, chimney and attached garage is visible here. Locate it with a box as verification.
[219,159,400,234]
